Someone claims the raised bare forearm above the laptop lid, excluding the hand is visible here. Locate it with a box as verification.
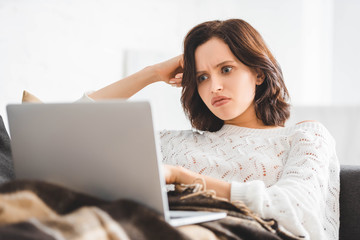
[89,67,158,100]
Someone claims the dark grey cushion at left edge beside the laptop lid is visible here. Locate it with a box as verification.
[0,116,14,184]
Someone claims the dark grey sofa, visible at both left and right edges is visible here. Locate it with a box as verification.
[0,116,360,240]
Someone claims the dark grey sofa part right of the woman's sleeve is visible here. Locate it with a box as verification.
[339,165,360,240]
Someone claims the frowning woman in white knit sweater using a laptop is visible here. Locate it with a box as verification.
[81,19,339,240]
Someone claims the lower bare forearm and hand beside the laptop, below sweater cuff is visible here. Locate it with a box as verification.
[177,167,231,200]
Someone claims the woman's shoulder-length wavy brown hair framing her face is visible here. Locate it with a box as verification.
[181,19,290,132]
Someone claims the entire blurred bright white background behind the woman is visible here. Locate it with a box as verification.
[0,0,360,163]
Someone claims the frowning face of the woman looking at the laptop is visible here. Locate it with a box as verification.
[195,37,263,126]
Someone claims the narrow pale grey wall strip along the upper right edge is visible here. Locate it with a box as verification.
[332,0,360,103]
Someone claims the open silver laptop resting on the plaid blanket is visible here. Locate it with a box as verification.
[7,101,226,226]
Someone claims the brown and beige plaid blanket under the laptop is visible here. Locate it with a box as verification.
[0,180,298,240]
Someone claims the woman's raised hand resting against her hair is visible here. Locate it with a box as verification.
[152,54,184,87]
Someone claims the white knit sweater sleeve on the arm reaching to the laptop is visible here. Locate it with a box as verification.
[231,125,340,239]
